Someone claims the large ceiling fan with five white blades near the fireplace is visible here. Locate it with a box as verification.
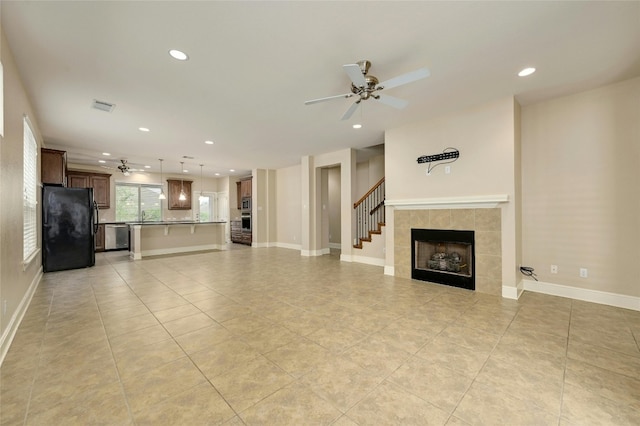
[304,60,431,120]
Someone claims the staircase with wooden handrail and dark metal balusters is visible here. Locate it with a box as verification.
[353,178,385,249]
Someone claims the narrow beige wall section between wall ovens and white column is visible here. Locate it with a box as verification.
[276,165,302,249]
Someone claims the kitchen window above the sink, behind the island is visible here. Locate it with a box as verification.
[116,183,162,222]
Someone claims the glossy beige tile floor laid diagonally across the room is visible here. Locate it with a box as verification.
[0,246,640,426]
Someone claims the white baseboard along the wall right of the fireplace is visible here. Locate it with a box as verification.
[522,280,640,311]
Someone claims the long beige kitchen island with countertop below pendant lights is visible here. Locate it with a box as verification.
[129,221,227,260]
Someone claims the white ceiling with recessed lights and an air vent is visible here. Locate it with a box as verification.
[0,0,640,176]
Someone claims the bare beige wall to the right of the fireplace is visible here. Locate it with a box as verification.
[522,78,640,297]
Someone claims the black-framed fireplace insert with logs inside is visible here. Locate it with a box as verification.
[411,229,476,290]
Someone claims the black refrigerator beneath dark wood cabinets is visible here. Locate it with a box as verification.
[42,185,98,272]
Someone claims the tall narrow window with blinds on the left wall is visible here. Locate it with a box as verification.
[22,117,38,263]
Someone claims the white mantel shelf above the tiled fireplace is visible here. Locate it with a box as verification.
[384,194,509,210]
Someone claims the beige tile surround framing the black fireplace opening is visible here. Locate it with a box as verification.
[394,208,502,296]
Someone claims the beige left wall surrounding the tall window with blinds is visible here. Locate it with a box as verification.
[0,30,42,362]
